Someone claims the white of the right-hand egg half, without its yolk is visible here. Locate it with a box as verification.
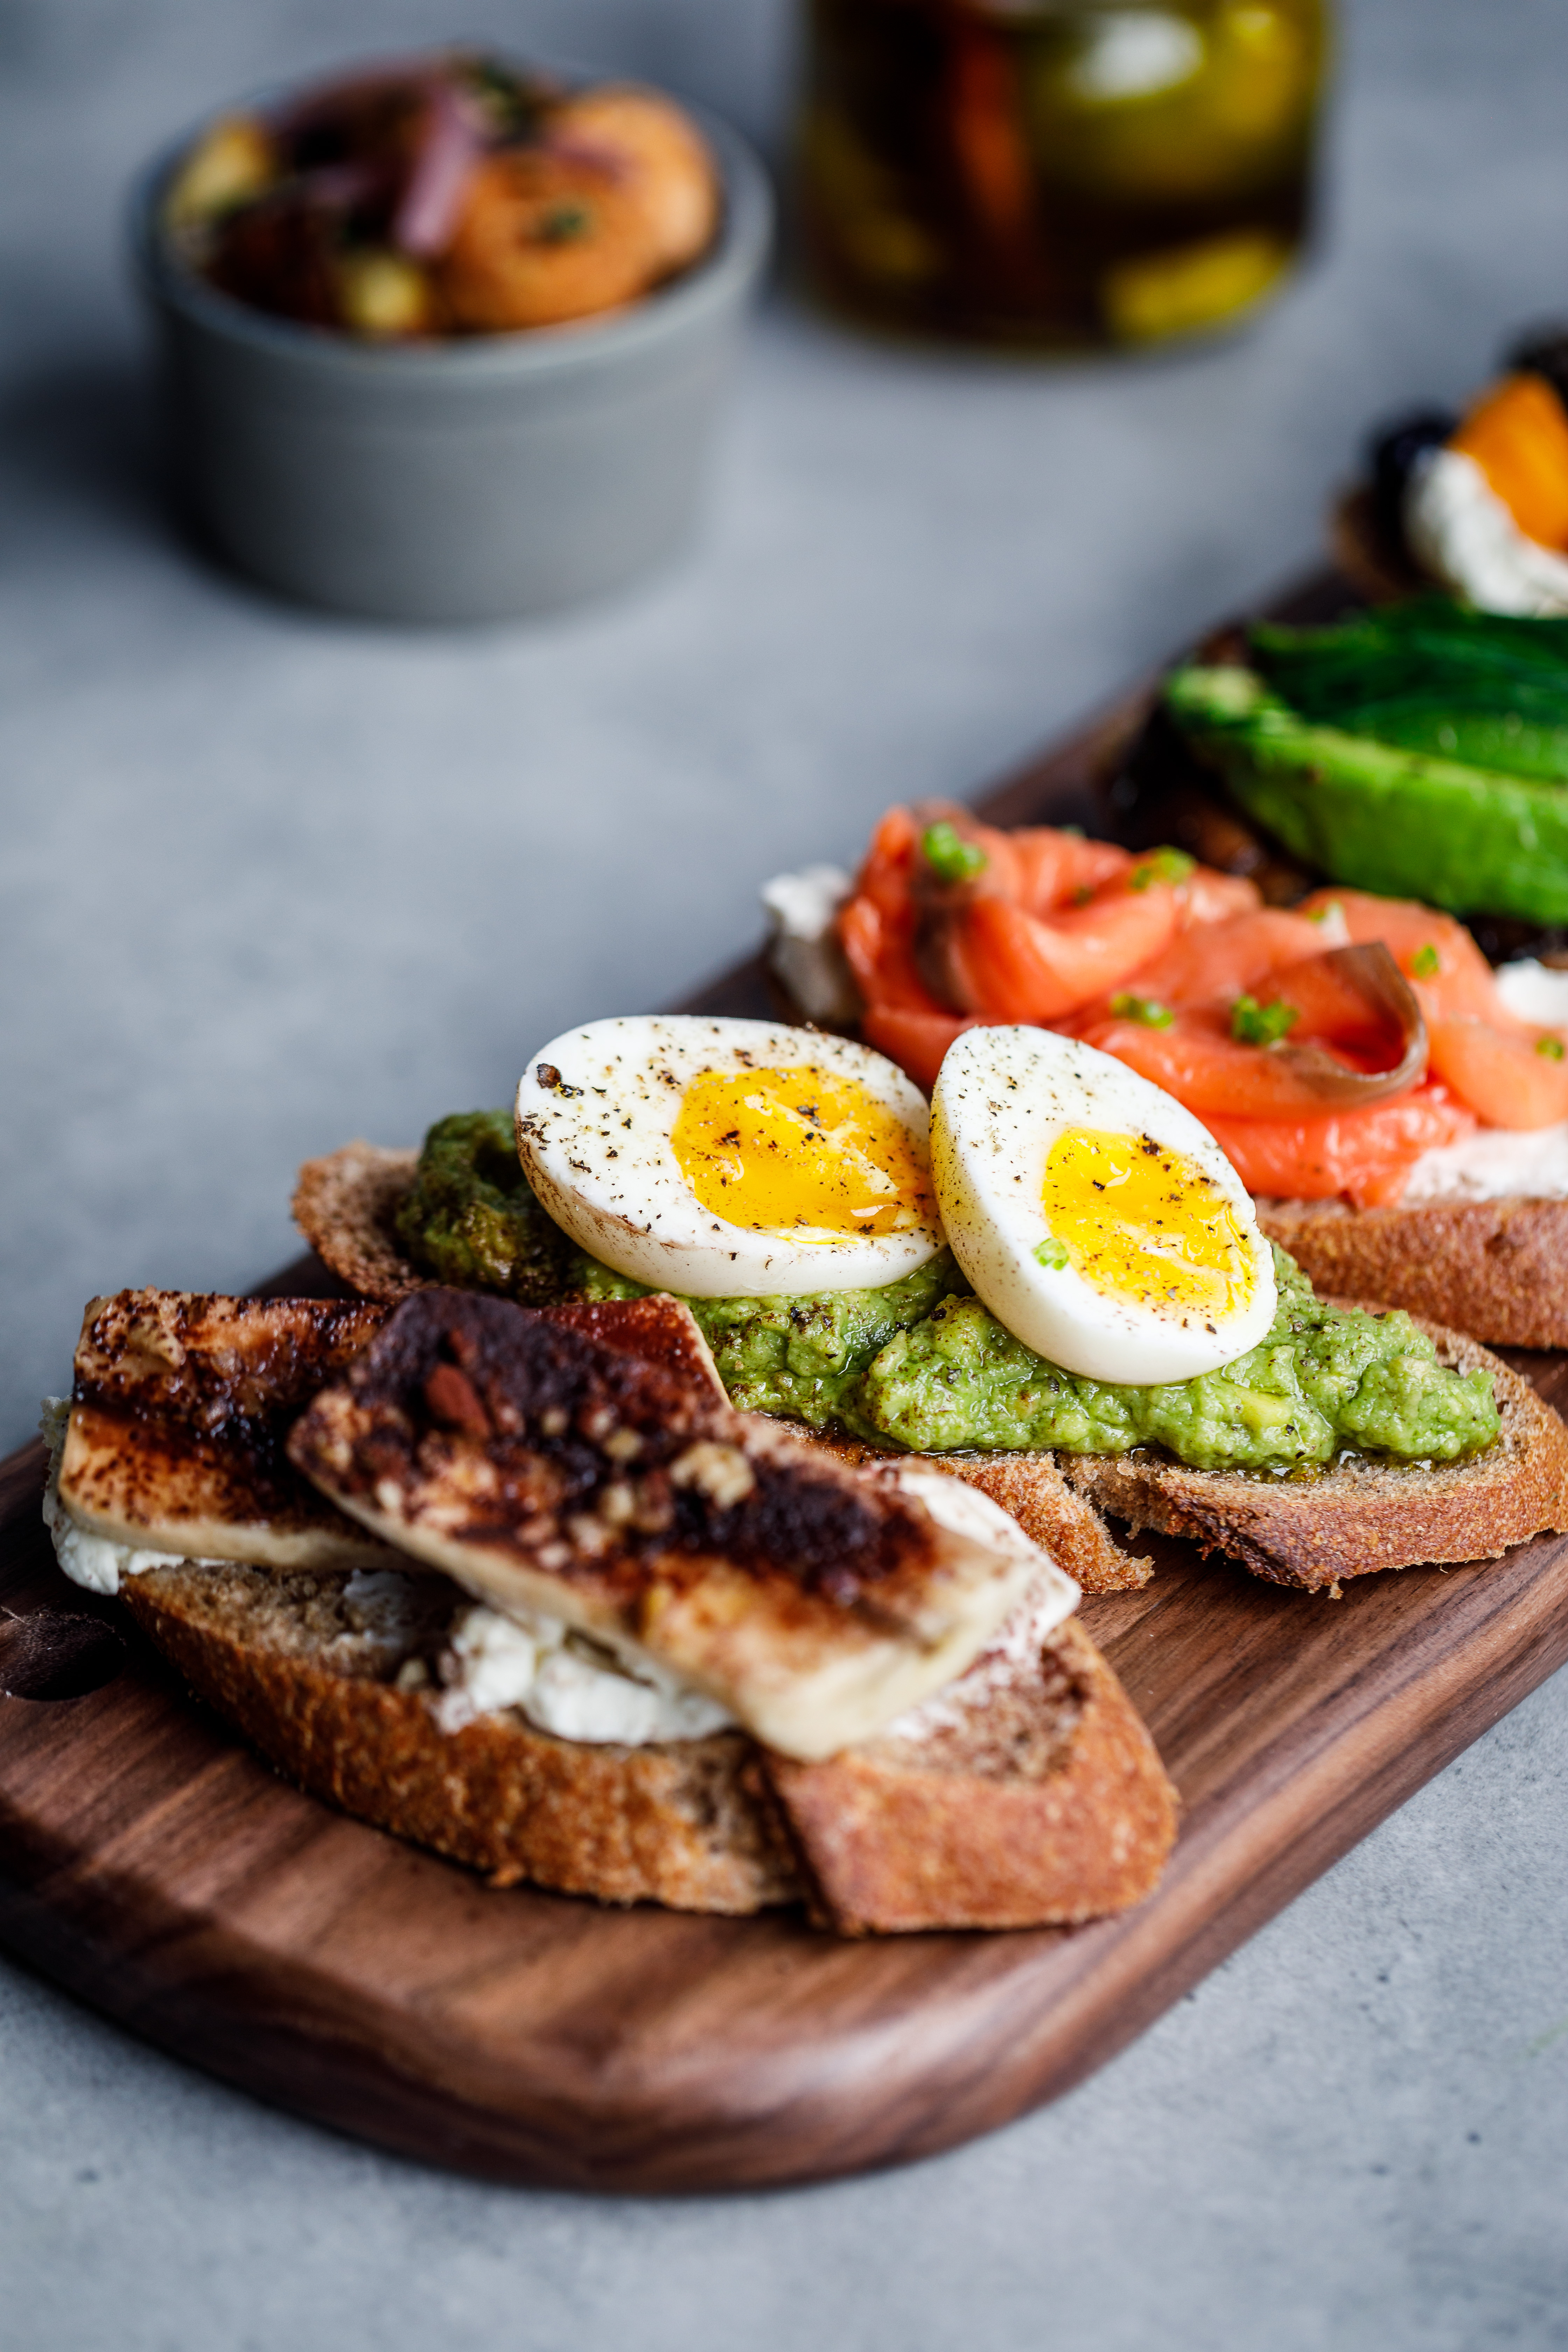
[931,1028,1274,1385]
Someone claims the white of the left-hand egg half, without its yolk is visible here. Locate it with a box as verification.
[517,1014,943,1298]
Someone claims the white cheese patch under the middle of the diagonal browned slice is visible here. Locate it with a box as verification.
[435,1606,734,1748]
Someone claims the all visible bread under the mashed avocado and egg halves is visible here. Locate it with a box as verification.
[294,1146,1568,1592]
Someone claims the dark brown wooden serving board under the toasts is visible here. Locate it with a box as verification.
[0,560,1568,2190]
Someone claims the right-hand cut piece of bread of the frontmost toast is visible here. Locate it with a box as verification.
[764,1620,1178,1936]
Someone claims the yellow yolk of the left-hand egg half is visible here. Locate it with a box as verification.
[670,1063,936,1242]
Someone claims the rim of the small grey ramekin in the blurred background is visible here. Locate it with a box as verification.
[127,68,774,383]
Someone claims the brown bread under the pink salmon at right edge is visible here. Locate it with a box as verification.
[1258,1199,1568,1348]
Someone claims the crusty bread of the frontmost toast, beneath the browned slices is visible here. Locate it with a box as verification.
[125,1567,1175,1936]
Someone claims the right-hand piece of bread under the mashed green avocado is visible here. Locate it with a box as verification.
[1065,1301,1568,1592]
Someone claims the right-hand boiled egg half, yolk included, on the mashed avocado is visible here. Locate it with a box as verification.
[931,1028,1274,1385]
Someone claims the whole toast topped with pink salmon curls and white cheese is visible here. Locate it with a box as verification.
[790,814,1568,1348]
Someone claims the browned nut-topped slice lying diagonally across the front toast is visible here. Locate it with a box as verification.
[289,1289,1077,1759]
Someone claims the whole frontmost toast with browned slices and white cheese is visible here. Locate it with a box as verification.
[47,1291,1175,1933]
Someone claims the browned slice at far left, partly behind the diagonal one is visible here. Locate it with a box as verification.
[59,1291,402,1571]
